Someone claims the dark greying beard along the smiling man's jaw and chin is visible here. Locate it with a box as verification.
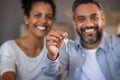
[77,27,102,44]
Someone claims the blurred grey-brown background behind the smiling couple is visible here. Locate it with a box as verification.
[0,0,120,45]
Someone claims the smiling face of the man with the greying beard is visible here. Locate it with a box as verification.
[73,3,105,44]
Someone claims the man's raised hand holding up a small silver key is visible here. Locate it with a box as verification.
[46,30,68,60]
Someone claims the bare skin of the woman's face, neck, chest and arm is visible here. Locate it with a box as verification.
[2,2,53,80]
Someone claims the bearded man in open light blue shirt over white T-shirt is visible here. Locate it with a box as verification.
[42,0,120,80]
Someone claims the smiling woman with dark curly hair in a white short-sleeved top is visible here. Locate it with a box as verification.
[0,0,58,80]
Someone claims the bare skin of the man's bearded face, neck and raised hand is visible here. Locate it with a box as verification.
[46,3,105,60]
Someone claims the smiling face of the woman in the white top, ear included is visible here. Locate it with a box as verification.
[25,2,54,38]
